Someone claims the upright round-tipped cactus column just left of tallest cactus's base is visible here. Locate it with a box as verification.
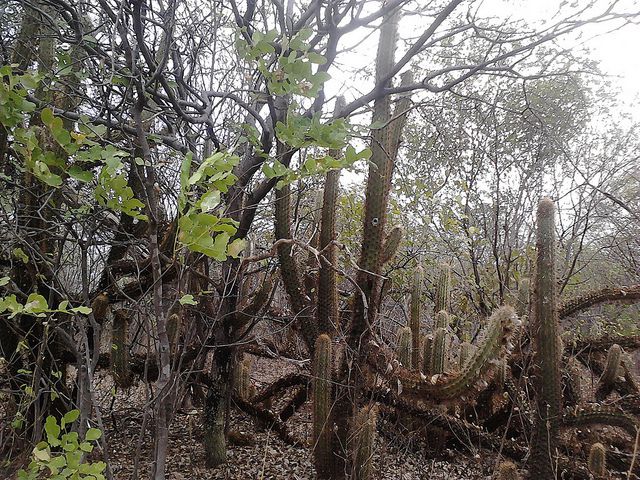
[313,334,334,479]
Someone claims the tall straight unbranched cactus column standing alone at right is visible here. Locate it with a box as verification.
[529,198,562,480]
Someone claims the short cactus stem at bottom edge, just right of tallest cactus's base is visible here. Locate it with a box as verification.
[351,406,378,480]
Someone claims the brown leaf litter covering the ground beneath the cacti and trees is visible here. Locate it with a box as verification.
[0,357,504,480]
